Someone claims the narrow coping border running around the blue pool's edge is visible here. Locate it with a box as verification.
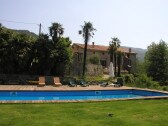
[0,88,168,104]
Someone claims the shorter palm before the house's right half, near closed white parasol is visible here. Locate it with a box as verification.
[109,37,121,76]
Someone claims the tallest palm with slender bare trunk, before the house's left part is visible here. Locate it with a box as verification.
[79,22,96,77]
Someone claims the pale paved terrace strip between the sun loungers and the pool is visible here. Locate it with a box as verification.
[0,85,132,91]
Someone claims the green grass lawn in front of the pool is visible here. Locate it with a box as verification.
[0,99,168,126]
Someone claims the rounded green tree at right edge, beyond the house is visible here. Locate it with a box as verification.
[145,40,168,84]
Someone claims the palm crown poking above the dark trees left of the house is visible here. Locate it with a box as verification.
[49,23,64,42]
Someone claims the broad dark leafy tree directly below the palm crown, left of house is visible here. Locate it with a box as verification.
[33,34,72,76]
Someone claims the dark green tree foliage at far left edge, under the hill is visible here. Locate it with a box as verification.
[0,27,35,74]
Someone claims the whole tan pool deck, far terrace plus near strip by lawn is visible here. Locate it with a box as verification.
[0,85,168,103]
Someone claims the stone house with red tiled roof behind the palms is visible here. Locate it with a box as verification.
[72,42,136,74]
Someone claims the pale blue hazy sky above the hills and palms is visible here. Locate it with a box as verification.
[0,0,168,49]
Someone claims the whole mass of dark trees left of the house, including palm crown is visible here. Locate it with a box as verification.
[0,23,72,76]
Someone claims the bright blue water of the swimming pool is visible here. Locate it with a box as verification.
[0,89,168,100]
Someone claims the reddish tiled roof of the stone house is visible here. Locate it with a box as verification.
[73,43,135,53]
